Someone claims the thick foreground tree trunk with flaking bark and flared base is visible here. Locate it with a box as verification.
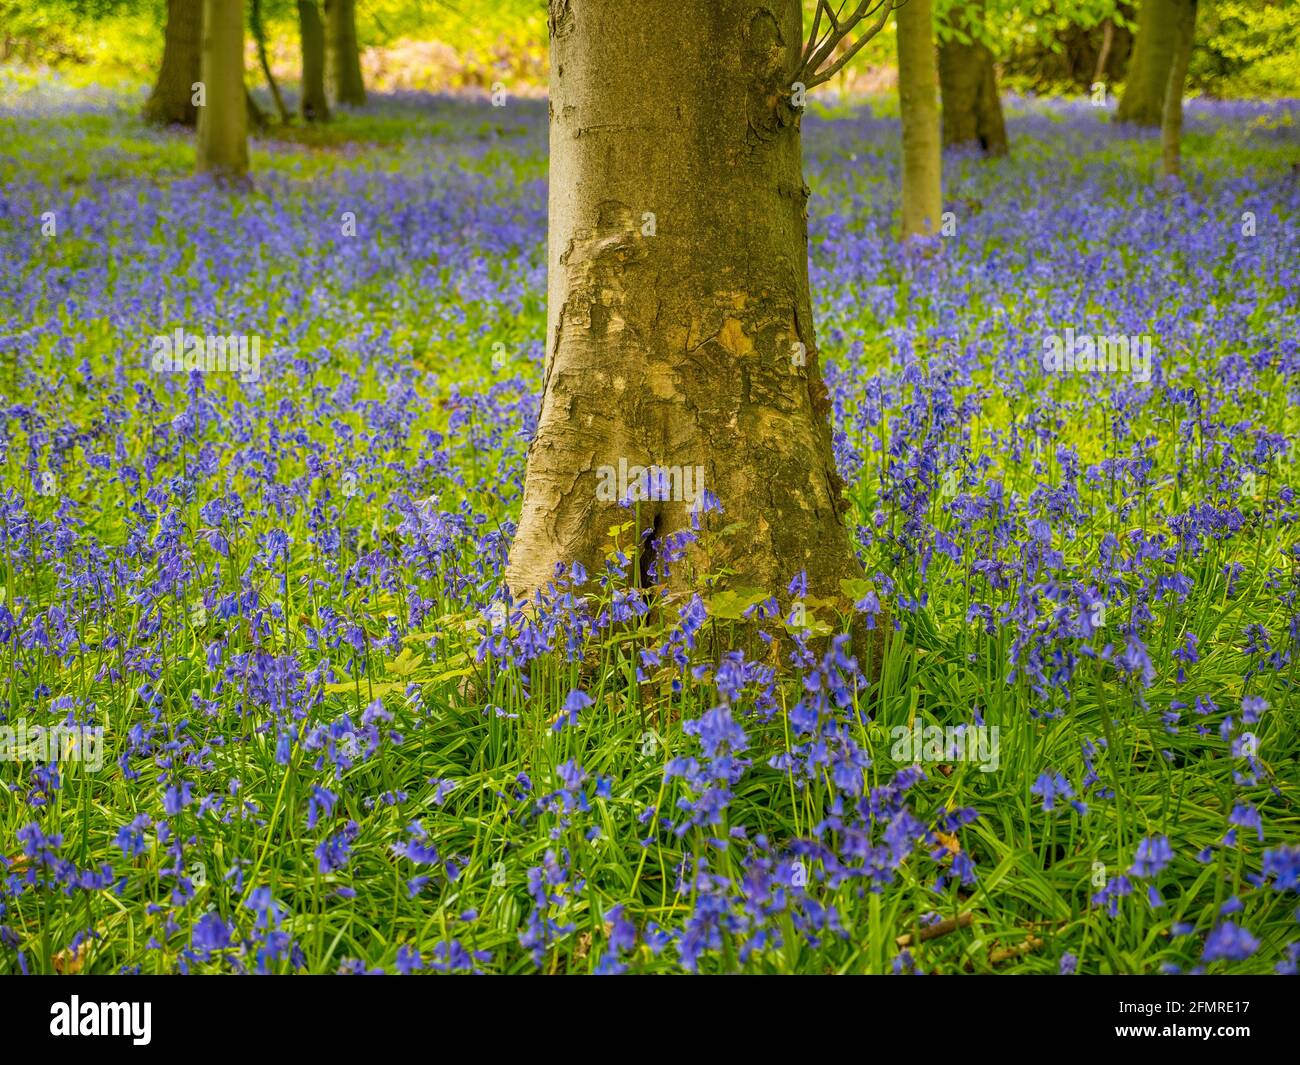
[508,0,862,650]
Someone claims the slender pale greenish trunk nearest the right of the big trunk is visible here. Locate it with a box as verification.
[894,0,944,239]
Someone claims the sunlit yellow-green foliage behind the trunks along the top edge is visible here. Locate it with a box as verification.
[0,0,1300,96]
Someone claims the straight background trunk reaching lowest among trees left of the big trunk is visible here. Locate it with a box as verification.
[198,0,248,179]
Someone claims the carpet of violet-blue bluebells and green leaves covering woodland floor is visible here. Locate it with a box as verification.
[0,75,1300,974]
